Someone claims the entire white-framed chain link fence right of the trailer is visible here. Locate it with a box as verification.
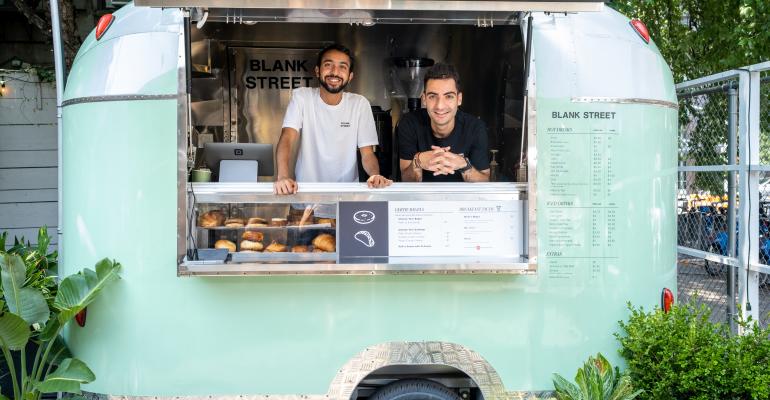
[677,62,770,329]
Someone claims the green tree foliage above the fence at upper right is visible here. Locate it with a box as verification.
[610,0,770,82]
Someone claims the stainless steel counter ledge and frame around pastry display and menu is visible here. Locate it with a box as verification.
[178,183,536,276]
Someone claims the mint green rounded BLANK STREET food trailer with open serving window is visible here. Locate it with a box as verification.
[60,0,677,399]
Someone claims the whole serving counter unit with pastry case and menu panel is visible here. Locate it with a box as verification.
[178,183,535,275]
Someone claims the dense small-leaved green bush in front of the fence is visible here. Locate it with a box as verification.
[616,303,770,399]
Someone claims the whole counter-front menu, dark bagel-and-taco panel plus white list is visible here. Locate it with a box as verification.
[338,200,524,261]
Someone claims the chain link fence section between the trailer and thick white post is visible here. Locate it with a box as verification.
[677,76,738,328]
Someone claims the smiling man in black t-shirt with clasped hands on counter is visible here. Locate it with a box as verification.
[396,63,489,182]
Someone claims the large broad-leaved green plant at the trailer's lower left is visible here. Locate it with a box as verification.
[0,249,121,400]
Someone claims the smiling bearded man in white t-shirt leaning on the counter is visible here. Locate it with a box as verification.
[273,44,393,194]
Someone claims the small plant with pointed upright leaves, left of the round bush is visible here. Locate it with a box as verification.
[553,353,642,400]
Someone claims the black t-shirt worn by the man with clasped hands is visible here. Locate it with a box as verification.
[396,108,489,182]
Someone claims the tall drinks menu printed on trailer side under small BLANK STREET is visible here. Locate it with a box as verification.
[538,105,623,281]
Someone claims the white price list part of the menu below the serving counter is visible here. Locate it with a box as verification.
[388,200,523,257]
